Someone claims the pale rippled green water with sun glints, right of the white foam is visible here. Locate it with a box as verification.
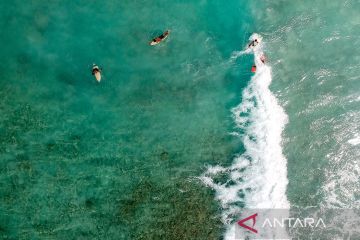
[250,1,360,208]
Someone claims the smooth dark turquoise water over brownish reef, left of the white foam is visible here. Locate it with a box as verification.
[0,1,253,239]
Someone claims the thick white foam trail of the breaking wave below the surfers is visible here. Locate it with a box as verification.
[200,34,290,239]
